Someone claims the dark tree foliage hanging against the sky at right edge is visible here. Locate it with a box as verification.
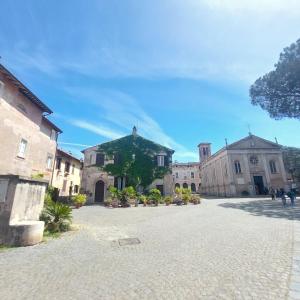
[250,39,300,119]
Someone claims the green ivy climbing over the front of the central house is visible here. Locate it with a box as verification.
[98,135,173,188]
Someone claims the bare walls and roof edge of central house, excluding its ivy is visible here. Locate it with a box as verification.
[81,128,174,203]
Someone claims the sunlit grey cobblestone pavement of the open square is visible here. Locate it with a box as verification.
[0,199,298,300]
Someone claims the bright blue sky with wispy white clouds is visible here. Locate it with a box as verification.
[0,0,300,161]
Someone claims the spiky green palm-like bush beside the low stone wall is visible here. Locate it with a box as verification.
[40,202,72,232]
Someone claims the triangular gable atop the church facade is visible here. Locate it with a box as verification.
[227,135,281,150]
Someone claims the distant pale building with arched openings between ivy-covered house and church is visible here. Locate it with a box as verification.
[172,162,201,193]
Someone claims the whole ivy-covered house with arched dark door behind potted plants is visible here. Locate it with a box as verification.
[81,127,174,203]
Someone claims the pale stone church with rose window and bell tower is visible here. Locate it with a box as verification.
[198,134,288,197]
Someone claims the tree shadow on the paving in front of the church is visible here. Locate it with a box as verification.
[219,200,300,220]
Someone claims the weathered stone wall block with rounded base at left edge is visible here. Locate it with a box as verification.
[0,175,47,246]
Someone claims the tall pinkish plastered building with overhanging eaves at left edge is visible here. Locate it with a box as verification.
[0,64,62,181]
